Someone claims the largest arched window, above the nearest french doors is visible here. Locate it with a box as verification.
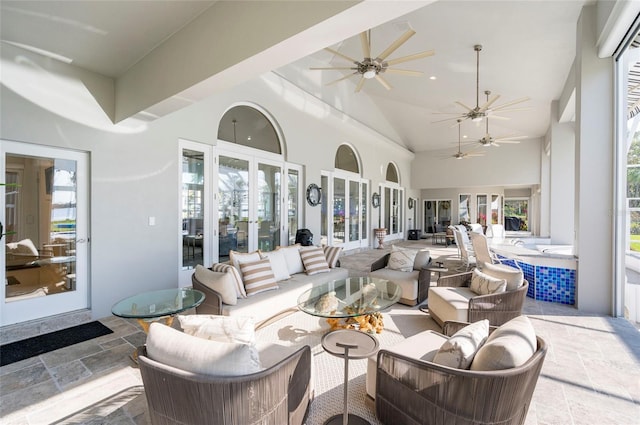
[218,105,282,154]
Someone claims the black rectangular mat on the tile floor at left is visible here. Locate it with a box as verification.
[0,322,113,366]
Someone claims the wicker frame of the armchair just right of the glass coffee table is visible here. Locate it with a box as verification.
[429,272,529,326]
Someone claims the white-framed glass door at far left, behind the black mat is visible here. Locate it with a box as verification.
[0,140,89,326]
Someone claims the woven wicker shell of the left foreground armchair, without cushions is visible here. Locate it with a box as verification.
[138,346,311,425]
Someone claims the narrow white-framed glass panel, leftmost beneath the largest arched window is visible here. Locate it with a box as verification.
[178,140,215,287]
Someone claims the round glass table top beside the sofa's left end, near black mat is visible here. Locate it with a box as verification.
[111,288,205,319]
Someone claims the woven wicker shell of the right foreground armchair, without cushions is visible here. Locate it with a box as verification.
[375,322,547,425]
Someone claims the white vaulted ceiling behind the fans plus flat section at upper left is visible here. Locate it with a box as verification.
[0,0,591,152]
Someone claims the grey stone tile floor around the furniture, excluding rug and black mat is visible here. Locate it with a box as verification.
[0,241,640,425]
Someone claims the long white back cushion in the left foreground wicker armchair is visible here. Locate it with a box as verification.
[146,322,262,376]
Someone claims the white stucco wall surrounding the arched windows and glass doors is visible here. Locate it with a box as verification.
[0,57,413,318]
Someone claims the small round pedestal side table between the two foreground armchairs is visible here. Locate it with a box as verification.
[322,329,379,425]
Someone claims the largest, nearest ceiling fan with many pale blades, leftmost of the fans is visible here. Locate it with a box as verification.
[309,28,435,93]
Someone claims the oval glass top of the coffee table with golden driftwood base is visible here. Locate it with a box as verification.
[298,277,402,318]
